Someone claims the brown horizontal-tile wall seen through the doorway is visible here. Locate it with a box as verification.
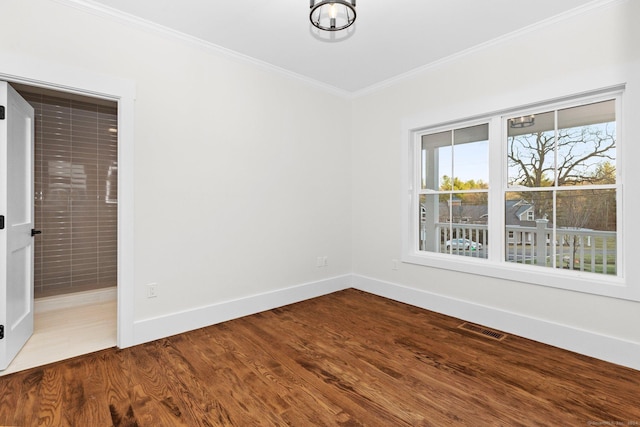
[22,92,118,298]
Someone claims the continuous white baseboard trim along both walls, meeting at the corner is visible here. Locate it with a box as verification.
[134,274,640,370]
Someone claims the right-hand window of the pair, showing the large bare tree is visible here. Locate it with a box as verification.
[504,99,617,275]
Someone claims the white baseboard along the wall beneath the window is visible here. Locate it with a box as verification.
[352,275,640,370]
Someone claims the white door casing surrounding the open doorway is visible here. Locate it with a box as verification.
[0,52,137,348]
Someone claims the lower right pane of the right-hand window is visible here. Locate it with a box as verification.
[556,190,617,274]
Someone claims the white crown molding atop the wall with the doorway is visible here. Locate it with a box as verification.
[52,0,351,99]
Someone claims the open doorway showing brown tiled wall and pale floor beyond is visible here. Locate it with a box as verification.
[0,83,118,375]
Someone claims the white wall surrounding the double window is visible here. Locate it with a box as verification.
[352,1,640,366]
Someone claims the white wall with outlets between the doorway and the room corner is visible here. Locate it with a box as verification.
[0,0,351,341]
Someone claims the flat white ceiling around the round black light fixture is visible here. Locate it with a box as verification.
[80,0,600,93]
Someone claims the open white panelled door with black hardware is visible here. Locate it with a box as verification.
[0,82,34,370]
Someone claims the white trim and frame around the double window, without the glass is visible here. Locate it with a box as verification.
[402,85,640,301]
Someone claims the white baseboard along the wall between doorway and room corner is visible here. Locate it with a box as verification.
[133,274,351,345]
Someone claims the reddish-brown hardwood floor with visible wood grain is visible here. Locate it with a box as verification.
[0,289,640,427]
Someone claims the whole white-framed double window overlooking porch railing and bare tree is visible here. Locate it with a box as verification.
[403,91,622,294]
